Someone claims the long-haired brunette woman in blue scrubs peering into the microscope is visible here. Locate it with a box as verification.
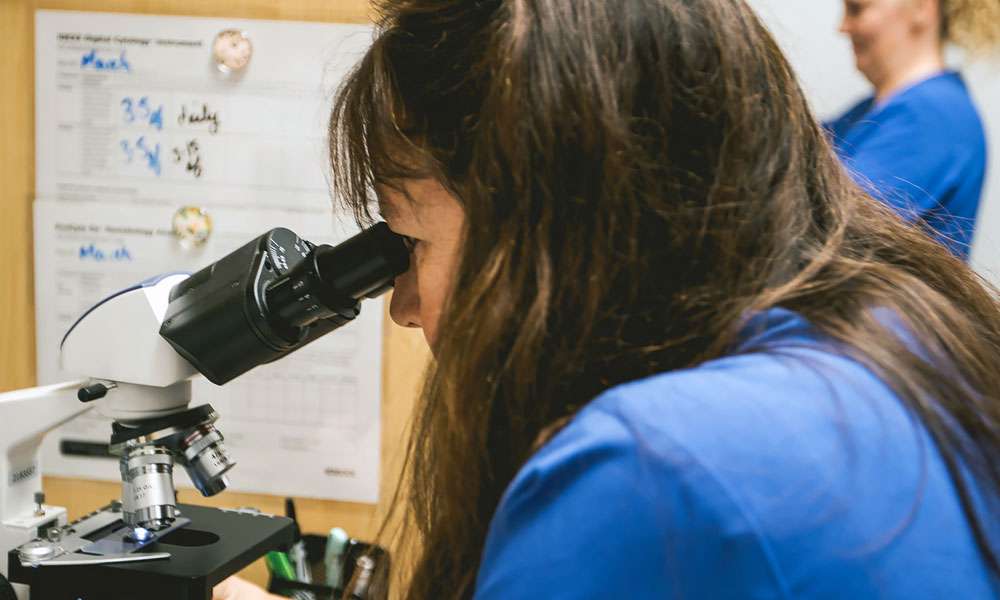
[215,0,1000,600]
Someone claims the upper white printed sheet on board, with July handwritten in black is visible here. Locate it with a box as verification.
[36,11,371,212]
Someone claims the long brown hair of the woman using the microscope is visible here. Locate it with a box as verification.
[330,0,1000,599]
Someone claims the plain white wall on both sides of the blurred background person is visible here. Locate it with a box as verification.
[748,0,1000,286]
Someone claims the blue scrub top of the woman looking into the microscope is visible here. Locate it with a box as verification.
[475,309,1000,600]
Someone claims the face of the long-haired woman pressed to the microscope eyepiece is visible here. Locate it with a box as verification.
[377,179,465,351]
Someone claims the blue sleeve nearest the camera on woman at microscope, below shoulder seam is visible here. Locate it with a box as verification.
[475,410,787,600]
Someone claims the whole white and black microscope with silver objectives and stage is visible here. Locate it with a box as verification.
[0,223,409,600]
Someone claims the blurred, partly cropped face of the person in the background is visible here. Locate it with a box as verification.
[840,0,924,86]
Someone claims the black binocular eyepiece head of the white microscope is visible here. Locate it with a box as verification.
[160,223,409,385]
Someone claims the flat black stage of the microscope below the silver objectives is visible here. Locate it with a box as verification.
[8,504,293,600]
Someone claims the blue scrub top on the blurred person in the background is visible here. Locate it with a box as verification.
[826,71,986,259]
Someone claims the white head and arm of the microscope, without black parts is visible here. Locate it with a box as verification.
[0,274,204,597]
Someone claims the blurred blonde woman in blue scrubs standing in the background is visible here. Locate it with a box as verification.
[827,0,1000,259]
